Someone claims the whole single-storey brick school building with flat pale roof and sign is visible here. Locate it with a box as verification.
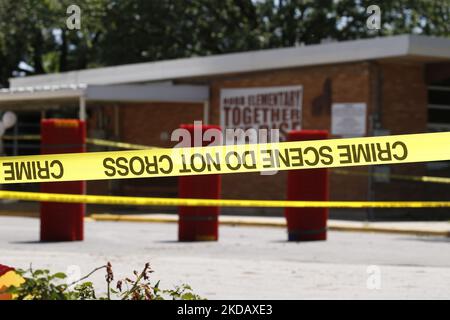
[0,35,450,217]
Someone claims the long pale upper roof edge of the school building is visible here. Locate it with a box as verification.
[9,35,450,88]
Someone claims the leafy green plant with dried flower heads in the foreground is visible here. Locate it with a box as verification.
[7,262,202,300]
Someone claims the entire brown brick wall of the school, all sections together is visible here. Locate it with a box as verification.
[86,61,434,218]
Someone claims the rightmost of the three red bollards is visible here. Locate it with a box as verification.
[285,130,328,241]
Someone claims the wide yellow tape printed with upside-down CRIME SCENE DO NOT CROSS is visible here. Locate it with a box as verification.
[0,132,450,184]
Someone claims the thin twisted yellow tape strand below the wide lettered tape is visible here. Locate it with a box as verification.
[0,190,450,209]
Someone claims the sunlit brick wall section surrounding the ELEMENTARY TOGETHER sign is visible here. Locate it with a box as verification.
[211,63,371,205]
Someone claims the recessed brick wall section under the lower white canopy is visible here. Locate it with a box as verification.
[88,103,203,198]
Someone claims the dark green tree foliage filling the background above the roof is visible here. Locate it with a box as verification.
[0,0,450,86]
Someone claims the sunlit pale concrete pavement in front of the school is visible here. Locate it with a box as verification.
[0,217,450,299]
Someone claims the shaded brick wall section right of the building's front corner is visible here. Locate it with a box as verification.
[374,62,428,200]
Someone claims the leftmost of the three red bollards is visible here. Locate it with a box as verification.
[41,119,86,241]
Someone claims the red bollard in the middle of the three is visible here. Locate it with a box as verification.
[178,125,221,241]
